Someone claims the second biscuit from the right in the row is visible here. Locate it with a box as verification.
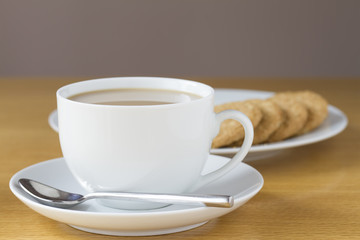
[268,94,309,142]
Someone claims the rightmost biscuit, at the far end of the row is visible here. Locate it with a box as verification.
[276,91,328,134]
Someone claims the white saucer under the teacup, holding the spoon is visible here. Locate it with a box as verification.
[10,155,264,236]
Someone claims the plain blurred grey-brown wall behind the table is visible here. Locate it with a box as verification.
[0,0,360,77]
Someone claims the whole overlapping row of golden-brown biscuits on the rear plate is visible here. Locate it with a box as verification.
[212,91,328,148]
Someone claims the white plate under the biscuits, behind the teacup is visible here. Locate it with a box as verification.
[48,89,348,161]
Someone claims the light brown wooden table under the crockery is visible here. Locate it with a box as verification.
[0,78,360,240]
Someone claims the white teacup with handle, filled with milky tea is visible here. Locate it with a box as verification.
[57,77,253,209]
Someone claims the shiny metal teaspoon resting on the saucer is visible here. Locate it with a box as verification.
[18,178,234,208]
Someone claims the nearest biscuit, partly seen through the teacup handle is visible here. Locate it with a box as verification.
[212,101,262,148]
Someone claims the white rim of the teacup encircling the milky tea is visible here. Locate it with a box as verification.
[56,76,214,108]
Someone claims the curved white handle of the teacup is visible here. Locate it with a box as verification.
[191,110,254,190]
